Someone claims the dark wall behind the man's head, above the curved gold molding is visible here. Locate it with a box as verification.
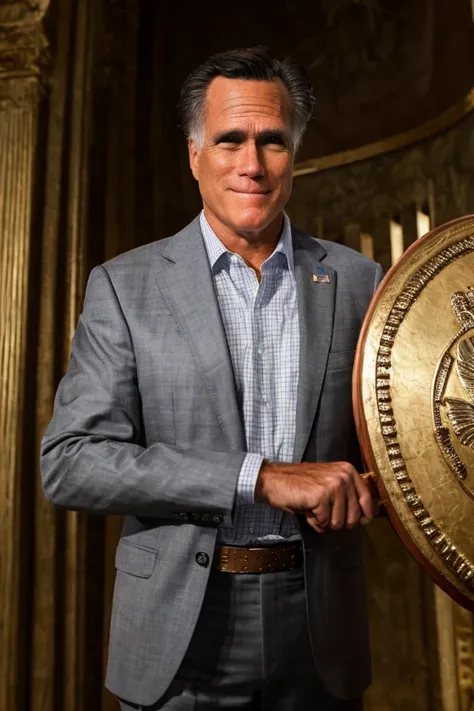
[132,0,474,240]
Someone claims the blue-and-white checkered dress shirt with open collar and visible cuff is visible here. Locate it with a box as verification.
[200,212,300,546]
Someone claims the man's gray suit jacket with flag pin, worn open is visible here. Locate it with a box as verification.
[41,220,381,705]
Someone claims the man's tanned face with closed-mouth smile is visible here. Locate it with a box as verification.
[189,77,294,238]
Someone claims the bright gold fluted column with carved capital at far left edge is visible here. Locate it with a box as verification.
[0,0,48,709]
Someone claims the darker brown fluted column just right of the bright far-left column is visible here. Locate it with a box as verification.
[29,0,103,711]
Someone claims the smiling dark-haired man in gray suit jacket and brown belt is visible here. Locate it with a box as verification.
[42,47,381,711]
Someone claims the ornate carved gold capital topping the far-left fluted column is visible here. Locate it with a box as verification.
[0,0,49,110]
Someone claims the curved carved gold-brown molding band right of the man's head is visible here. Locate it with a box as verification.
[290,108,474,236]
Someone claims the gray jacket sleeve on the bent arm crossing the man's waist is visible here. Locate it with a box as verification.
[41,267,245,526]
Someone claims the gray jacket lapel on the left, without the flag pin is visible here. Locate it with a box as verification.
[156,218,245,452]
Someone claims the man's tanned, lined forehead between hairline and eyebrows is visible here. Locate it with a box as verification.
[205,77,291,128]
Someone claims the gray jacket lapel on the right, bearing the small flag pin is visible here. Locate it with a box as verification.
[293,228,337,462]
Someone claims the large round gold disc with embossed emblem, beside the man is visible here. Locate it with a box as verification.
[353,216,474,610]
